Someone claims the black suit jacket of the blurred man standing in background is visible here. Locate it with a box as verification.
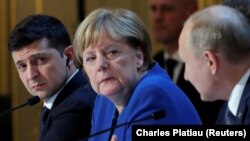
[154,51,223,125]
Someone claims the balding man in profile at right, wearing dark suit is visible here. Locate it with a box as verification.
[179,5,250,125]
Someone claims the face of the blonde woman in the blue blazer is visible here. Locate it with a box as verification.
[82,33,143,100]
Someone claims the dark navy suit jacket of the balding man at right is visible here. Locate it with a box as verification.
[216,77,250,125]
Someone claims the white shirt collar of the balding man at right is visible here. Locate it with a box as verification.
[228,68,250,116]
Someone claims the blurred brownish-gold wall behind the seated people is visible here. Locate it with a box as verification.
[0,0,223,141]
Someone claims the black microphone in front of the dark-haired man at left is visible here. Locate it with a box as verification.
[0,96,40,117]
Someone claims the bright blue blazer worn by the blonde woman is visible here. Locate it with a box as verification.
[89,64,201,141]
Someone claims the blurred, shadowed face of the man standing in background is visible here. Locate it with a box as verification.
[150,0,194,43]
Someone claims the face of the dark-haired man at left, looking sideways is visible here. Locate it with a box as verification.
[12,39,66,100]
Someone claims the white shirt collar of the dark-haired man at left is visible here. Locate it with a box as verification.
[44,69,79,109]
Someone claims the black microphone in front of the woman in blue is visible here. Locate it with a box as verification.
[86,110,166,139]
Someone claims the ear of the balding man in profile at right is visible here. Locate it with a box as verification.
[202,50,219,75]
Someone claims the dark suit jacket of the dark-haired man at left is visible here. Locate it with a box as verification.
[39,71,96,141]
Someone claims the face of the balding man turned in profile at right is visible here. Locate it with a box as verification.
[178,25,214,101]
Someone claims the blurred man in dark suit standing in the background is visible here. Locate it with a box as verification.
[150,0,222,125]
